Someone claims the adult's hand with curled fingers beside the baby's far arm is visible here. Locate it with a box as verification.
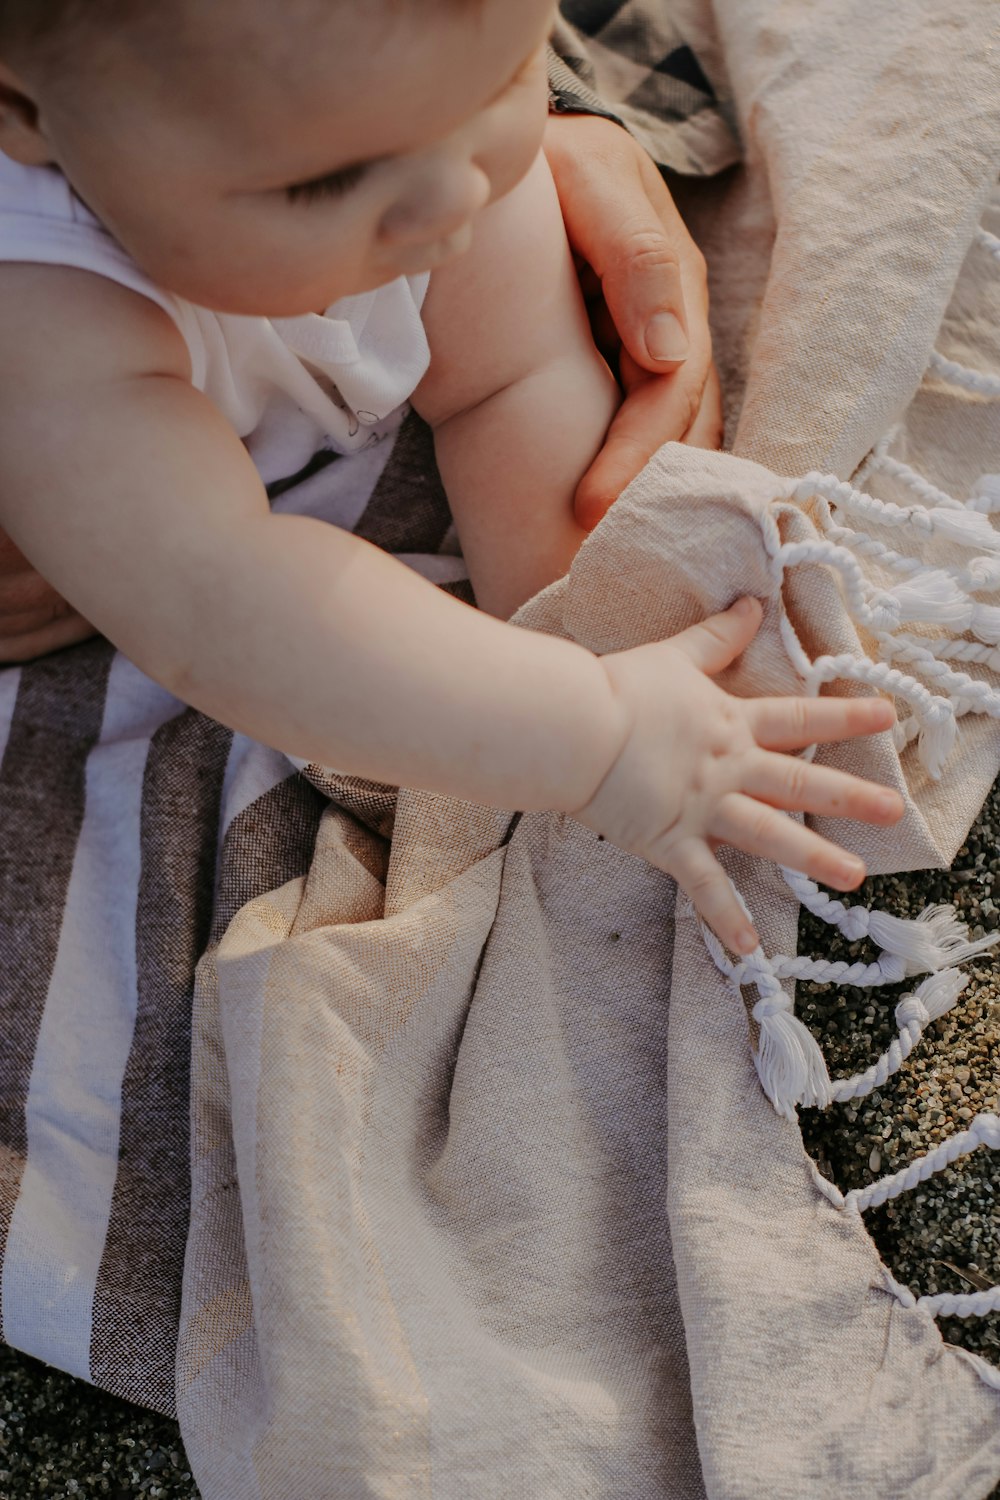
[544,114,723,530]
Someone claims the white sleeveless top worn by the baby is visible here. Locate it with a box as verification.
[0,153,430,482]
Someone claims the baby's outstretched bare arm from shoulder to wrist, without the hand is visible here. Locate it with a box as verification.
[0,266,621,809]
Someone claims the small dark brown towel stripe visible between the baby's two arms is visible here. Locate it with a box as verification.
[347,413,451,552]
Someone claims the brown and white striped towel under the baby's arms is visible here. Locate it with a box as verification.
[0,416,468,1413]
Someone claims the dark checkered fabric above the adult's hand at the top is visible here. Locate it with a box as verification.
[549,0,741,176]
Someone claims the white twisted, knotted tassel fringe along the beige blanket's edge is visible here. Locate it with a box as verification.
[702,217,1000,1391]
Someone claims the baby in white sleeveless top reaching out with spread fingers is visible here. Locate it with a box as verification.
[0,0,901,953]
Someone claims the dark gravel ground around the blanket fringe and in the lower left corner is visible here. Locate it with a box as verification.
[0,783,1000,1500]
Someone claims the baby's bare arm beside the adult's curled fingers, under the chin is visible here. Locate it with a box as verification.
[414,158,619,618]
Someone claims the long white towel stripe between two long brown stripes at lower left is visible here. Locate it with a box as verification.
[1,656,183,1380]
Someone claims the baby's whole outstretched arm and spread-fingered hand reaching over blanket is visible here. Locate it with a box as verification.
[0,266,901,951]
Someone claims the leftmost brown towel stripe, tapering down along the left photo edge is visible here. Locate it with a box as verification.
[0,641,114,1338]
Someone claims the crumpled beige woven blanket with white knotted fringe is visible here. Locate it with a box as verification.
[178,0,1000,1500]
